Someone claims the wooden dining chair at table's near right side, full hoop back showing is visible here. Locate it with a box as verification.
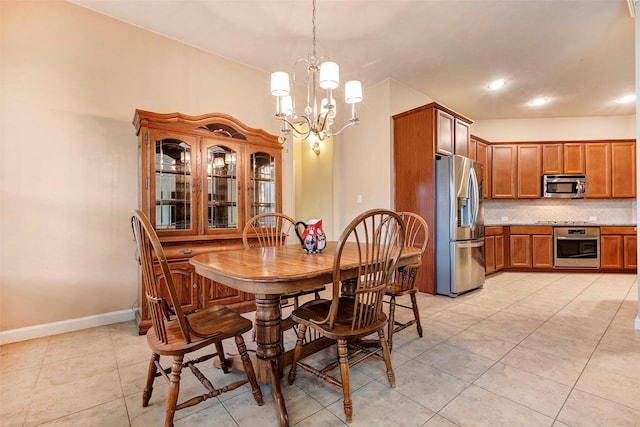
[289,209,404,422]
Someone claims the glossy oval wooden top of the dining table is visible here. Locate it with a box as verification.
[190,242,420,295]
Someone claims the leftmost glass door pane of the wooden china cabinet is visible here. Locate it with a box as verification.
[152,136,194,234]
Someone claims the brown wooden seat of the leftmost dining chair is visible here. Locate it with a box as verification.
[147,305,252,356]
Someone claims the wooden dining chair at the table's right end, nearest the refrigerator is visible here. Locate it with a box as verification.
[385,212,429,350]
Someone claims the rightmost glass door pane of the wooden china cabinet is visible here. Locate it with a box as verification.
[249,151,278,216]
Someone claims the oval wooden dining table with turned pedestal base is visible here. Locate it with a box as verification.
[190,241,421,427]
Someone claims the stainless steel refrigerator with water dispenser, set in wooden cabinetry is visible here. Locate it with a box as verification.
[435,156,484,297]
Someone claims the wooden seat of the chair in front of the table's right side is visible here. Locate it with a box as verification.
[291,297,387,340]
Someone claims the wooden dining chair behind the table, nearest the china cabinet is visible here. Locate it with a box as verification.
[242,212,325,308]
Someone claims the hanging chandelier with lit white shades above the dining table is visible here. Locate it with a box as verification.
[271,0,362,154]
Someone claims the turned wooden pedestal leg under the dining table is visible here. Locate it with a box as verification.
[256,295,289,427]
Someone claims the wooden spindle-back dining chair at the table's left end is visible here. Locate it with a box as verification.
[131,210,262,427]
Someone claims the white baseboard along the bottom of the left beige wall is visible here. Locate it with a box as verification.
[0,309,135,345]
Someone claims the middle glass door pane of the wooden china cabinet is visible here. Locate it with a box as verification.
[203,143,239,231]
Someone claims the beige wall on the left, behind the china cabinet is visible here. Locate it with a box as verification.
[0,0,293,331]
